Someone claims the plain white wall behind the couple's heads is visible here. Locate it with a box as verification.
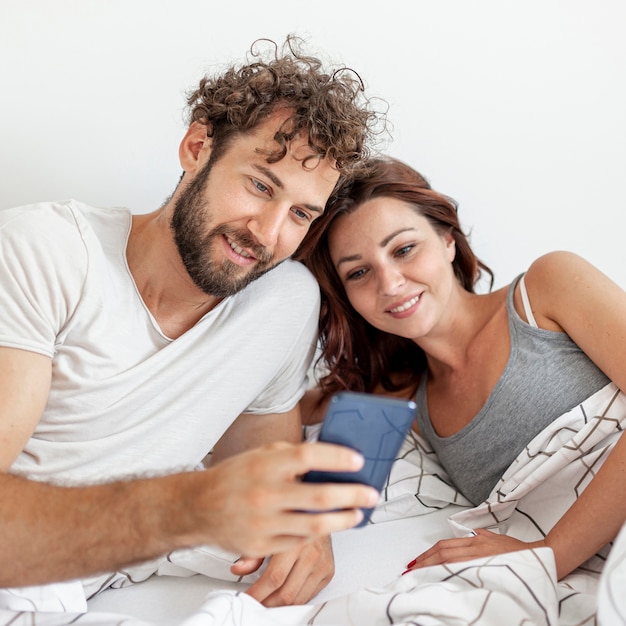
[0,0,626,287]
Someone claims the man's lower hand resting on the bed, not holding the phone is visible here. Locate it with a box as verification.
[231,537,335,607]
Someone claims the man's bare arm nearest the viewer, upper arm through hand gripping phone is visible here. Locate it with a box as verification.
[0,348,377,587]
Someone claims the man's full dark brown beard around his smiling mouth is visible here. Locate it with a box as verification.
[170,159,274,298]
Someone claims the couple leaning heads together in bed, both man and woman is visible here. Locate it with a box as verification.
[0,33,626,606]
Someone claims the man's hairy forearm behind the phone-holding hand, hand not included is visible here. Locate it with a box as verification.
[0,473,190,587]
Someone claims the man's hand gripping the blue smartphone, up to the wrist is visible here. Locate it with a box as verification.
[186,442,378,558]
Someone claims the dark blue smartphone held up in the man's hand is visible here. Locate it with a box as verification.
[302,391,417,526]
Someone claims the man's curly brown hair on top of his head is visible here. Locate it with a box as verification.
[187,35,382,175]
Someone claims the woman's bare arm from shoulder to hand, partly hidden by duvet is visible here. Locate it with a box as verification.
[409,252,626,579]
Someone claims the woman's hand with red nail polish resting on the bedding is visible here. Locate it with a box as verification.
[403,528,546,574]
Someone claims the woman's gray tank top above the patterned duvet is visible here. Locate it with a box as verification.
[416,275,609,504]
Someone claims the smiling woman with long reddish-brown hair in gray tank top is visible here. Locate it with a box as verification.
[299,159,626,579]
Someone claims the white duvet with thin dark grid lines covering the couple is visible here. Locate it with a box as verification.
[0,384,626,626]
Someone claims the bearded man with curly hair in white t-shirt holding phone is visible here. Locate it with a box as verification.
[0,38,377,606]
